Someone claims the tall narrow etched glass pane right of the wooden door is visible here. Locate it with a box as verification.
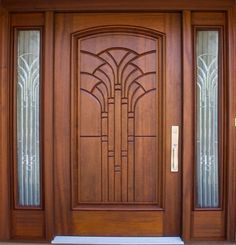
[196,31,219,208]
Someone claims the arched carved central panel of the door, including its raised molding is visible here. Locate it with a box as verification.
[71,27,164,208]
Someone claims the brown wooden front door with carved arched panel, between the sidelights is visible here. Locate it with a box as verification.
[54,13,182,236]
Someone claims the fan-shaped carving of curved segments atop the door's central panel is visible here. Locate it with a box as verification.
[81,47,156,112]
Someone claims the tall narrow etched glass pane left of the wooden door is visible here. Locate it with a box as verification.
[17,30,40,206]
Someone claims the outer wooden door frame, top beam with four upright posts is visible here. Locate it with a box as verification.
[0,0,236,241]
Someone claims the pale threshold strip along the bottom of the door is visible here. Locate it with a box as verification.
[51,236,184,245]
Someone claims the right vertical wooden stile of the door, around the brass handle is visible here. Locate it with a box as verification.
[163,14,183,236]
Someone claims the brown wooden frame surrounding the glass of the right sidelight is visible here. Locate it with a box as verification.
[191,18,228,240]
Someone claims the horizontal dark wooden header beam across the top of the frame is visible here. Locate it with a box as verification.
[2,0,235,11]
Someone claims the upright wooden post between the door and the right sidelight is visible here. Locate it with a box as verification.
[182,11,194,241]
